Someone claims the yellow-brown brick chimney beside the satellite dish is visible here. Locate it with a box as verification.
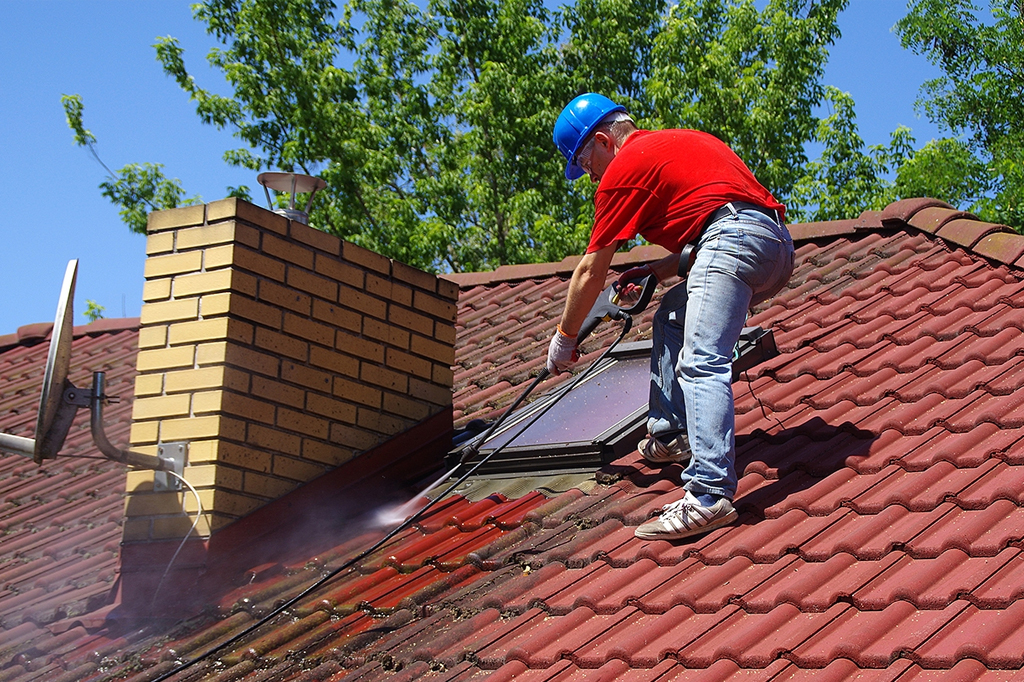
[124,199,459,543]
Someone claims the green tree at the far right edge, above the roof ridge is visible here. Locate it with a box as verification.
[896,0,1024,229]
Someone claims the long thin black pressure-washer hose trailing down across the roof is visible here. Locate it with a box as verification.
[153,315,633,682]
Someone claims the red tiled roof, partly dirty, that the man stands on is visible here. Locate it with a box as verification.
[9,200,1024,681]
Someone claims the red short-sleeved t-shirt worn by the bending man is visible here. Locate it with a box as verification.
[587,130,785,253]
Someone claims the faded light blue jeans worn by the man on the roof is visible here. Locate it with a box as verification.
[647,211,793,500]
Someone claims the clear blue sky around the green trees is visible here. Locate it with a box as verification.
[0,0,938,335]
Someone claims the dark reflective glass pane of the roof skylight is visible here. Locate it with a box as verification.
[481,356,650,450]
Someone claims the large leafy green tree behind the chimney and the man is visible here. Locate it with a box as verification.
[66,0,864,271]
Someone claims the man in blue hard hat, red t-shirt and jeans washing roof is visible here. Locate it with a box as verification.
[547,93,793,540]
